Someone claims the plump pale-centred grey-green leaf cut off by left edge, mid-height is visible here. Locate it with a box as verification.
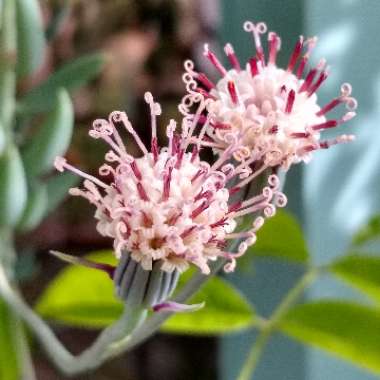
[0,145,28,226]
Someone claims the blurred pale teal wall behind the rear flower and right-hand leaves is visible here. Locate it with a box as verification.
[219,0,380,380]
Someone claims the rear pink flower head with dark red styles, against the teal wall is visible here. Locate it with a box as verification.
[180,21,357,169]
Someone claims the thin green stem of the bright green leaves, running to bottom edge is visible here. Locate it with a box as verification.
[238,269,318,380]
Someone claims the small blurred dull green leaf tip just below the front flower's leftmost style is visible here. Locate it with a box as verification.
[46,172,80,213]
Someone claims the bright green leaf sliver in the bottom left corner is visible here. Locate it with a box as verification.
[0,300,21,380]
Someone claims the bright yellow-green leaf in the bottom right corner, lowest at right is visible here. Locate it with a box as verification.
[280,301,380,373]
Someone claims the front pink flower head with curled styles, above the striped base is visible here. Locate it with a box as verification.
[56,93,286,274]
